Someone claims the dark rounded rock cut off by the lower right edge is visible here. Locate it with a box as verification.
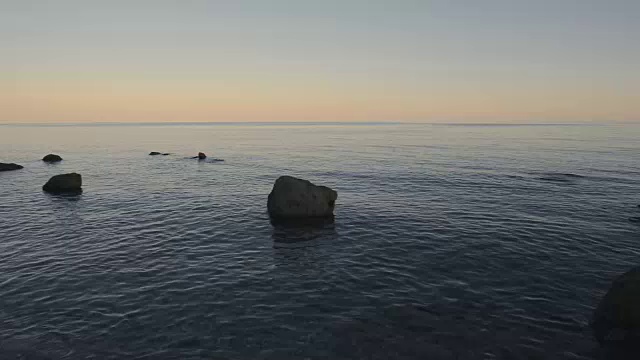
[591,267,640,350]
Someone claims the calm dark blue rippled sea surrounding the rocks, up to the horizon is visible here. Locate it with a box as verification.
[0,124,640,359]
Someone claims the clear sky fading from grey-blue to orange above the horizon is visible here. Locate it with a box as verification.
[0,0,640,123]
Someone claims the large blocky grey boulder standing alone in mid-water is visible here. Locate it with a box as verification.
[267,176,338,221]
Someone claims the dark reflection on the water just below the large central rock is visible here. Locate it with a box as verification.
[271,217,338,248]
